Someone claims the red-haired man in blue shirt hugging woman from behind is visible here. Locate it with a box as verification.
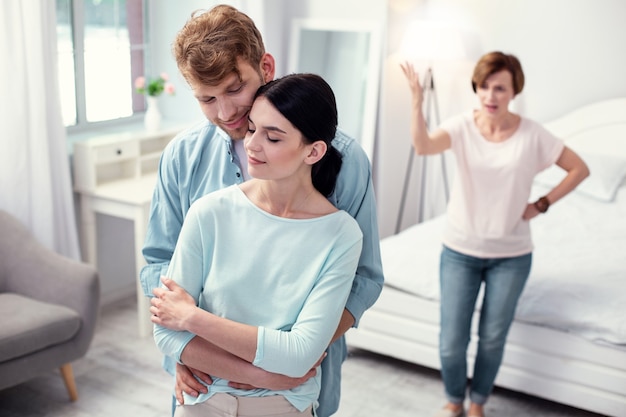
[141,5,383,417]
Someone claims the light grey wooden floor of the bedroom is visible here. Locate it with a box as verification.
[0,298,597,417]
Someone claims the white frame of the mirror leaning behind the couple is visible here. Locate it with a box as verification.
[288,18,382,162]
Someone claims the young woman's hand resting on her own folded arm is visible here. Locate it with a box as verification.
[150,277,197,331]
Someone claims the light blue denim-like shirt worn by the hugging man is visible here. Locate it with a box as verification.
[140,121,383,417]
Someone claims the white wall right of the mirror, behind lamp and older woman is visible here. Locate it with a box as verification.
[375,0,626,237]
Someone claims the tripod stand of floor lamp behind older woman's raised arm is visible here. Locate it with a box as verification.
[395,67,450,233]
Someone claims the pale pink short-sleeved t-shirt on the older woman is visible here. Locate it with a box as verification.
[440,112,564,258]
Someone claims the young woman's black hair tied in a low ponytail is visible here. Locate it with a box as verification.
[254,74,341,197]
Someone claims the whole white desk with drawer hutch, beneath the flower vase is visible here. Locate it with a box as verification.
[74,127,183,336]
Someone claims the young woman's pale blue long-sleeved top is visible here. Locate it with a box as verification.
[155,185,362,410]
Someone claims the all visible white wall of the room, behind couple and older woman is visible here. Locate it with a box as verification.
[99,0,626,302]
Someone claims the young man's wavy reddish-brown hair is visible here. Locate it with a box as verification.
[172,5,265,85]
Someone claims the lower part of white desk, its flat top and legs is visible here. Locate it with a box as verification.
[80,174,156,337]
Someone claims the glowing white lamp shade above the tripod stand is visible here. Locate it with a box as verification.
[400,20,467,61]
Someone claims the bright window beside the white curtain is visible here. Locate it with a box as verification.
[56,0,146,130]
